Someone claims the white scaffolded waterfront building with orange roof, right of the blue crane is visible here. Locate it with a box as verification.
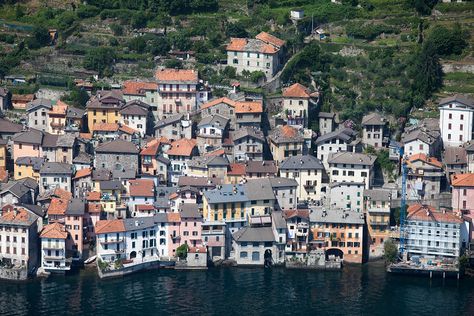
[405,204,463,259]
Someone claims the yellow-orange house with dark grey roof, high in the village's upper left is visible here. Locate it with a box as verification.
[86,90,125,132]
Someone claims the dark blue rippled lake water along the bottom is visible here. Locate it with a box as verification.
[0,263,474,316]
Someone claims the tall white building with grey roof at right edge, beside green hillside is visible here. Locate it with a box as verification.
[439,95,474,146]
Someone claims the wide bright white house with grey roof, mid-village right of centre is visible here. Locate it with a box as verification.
[328,152,377,189]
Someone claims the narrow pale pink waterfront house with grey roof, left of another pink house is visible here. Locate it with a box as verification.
[179,203,202,247]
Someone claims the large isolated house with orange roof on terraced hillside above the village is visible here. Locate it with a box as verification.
[226,32,285,79]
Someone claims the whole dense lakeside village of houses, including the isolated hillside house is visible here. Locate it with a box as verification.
[0,33,474,280]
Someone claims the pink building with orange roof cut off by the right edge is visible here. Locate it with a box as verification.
[451,173,474,215]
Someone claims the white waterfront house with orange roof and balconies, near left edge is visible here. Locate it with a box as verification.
[40,222,71,272]
